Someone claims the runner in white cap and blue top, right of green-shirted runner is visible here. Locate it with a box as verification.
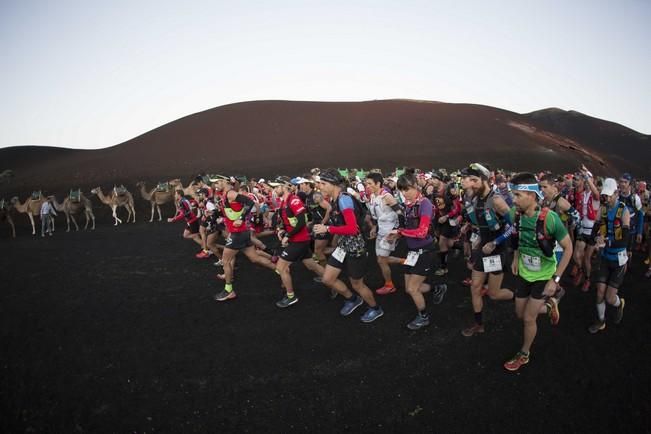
[588,178,631,334]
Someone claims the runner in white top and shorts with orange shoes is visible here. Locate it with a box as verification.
[365,172,404,295]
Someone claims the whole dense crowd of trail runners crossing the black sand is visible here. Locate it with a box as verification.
[168,163,651,371]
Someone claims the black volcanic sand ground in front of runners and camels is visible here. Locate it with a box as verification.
[0,219,651,433]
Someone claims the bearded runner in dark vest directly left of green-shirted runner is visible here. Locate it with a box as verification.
[461,163,514,337]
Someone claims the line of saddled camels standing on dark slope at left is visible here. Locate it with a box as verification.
[0,175,204,238]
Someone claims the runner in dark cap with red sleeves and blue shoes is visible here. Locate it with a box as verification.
[314,169,384,323]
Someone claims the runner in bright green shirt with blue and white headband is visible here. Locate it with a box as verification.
[504,173,572,371]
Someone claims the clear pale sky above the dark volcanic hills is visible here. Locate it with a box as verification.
[0,0,651,148]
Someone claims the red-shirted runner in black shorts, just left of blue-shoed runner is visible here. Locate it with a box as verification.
[274,178,324,308]
